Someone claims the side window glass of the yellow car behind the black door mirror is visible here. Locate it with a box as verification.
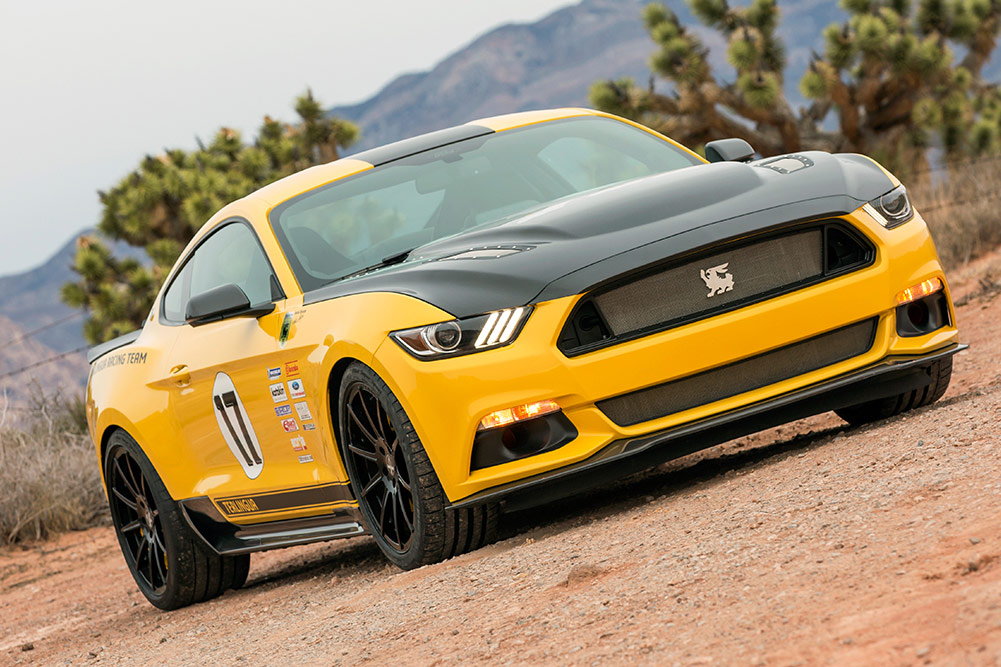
[163,222,275,322]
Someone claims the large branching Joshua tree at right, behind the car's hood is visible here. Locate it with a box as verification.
[591,0,1001,167]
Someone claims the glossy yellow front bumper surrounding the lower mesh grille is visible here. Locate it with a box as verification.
[372,205,959,504]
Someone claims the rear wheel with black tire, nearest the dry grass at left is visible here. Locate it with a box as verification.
[104,431,250,610]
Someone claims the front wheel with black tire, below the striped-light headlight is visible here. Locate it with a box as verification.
[337,363,498,570]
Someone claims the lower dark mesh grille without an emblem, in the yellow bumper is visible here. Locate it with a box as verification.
[597,317,877,426]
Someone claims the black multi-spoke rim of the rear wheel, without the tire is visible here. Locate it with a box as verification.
[108,449,168,595]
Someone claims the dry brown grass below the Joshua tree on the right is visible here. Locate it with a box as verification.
[908,158,1001,269]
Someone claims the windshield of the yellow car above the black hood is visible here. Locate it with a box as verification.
[271,116,701,291]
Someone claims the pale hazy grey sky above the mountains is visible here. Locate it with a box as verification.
[0,0,576,275]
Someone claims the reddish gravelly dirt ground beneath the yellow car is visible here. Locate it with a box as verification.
[0,253,1001,665]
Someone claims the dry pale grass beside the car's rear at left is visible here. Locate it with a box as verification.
[0,398,108,544]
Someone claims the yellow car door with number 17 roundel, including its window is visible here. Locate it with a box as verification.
[161,220,317,500]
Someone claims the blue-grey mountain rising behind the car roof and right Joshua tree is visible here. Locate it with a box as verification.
[330,0,844,150]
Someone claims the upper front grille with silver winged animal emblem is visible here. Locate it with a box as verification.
[558,220,875,357]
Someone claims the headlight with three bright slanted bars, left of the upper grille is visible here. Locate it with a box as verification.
[389,305,532,361]
